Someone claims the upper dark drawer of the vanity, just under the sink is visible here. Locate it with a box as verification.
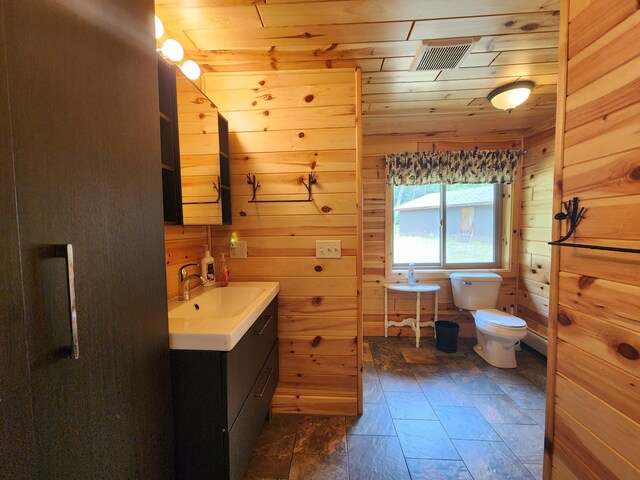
[225,296,278,429]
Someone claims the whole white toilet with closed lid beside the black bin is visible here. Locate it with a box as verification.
[451,273,527,368]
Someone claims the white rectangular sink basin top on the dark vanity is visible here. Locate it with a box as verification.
[169,282,280,351]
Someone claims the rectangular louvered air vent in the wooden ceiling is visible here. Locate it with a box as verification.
[409,38,475,72]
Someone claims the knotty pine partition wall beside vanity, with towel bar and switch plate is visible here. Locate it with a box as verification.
[204,69,361,415]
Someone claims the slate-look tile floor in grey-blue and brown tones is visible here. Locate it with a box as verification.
[245,337,546,480]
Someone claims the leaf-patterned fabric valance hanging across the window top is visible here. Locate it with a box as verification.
[385,150,522,185]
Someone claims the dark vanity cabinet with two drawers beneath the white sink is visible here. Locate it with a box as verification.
[171,296,278,480]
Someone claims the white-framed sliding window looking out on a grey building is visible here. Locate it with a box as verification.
[391,184,502,268]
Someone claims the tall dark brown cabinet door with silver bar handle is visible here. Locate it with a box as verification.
[1,0,172,479]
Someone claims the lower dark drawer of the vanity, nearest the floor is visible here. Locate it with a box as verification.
[228,342,278,480]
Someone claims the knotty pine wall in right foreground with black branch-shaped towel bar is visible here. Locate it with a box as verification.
[546,0,640,480]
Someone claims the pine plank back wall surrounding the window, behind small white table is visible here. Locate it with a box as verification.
[362,136,521,337]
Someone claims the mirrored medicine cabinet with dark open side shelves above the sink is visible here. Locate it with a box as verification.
[158,58,231,225]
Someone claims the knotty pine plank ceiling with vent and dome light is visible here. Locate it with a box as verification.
[156,0,560,136]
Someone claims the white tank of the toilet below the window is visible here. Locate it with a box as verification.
[450,272,502,310]
